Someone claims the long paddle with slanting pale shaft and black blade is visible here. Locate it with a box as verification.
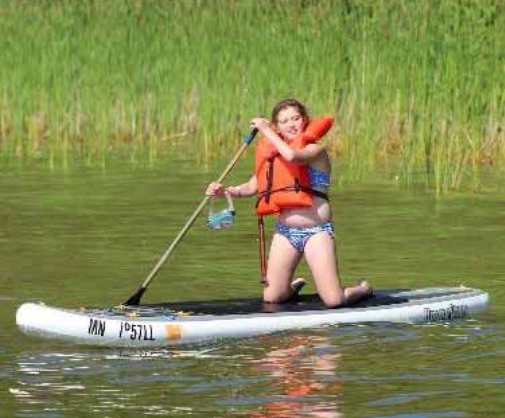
[123,129,258,305]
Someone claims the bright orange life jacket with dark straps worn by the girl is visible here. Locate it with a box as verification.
[256,117,333,216]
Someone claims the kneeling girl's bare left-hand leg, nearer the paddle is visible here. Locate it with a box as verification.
[263,233,302,303]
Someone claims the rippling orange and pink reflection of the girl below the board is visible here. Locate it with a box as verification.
[250,335,344,418]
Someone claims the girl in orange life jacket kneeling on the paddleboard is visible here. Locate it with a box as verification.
[207,100,372,308]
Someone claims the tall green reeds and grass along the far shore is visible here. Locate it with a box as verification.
[0,0,505,194]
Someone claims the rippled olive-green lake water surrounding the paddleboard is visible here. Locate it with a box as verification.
[0,162,505,418]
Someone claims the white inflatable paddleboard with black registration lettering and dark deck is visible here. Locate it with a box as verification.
[16,287,488,347]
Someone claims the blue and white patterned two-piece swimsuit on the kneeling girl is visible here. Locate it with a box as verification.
[276,166,335,254]
